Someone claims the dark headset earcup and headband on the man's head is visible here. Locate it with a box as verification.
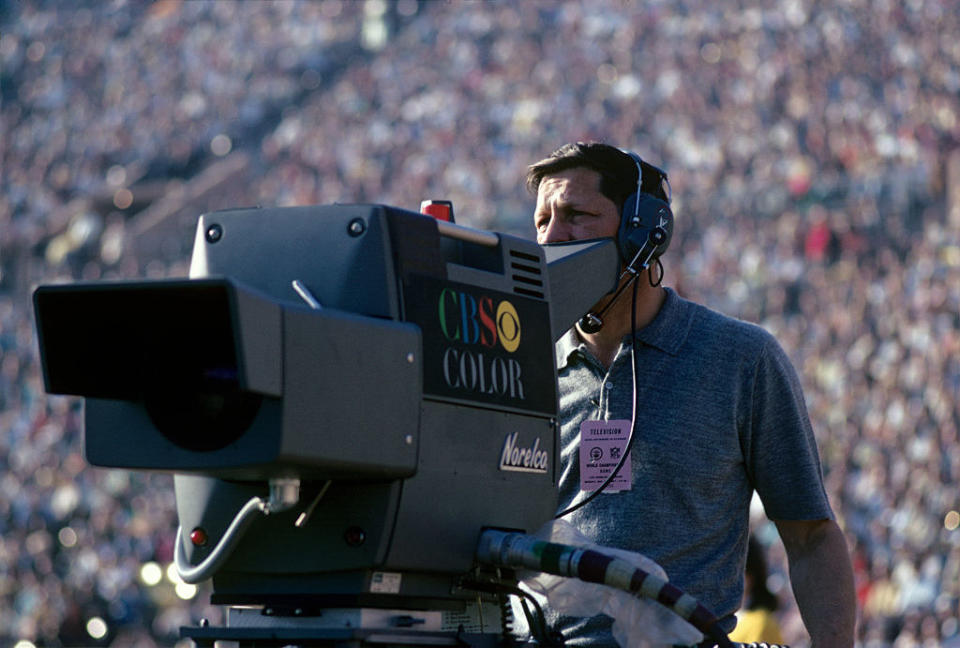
[617,151,673,263]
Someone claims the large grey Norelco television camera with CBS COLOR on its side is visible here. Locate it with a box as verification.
[34,205,632,646]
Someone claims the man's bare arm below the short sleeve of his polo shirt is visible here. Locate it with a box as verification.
[774,520,857,648]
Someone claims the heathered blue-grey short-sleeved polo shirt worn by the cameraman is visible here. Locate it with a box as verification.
[556,288,833,645]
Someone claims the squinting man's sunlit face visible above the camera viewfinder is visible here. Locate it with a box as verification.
[533,167,620,244]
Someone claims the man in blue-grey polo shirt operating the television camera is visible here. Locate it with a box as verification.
[527,143,856,647]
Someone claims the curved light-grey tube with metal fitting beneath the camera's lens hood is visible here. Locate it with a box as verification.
[174,478,300,584]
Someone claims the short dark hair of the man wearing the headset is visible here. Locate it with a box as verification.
[527,142,667,209]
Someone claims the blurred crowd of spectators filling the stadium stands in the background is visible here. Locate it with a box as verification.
[0,0,960,648]
